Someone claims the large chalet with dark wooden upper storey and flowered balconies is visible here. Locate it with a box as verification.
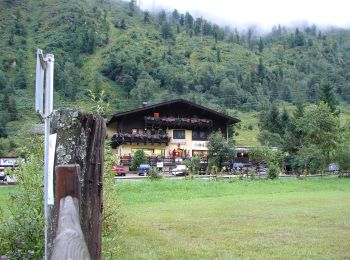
[107,99,240,168]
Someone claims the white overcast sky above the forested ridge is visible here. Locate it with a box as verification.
[137,0,350,30]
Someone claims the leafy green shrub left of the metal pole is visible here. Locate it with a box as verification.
[0,138,44,259]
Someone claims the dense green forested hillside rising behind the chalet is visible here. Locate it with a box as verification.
[0,0,350,155]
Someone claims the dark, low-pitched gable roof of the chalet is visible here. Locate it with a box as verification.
[107,98,241,125]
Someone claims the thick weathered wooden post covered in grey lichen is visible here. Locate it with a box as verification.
[50,109,106,259]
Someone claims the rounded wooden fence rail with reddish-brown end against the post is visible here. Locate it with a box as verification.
[50,164,91,260]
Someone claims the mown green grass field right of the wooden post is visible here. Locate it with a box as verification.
[112,179,350,259]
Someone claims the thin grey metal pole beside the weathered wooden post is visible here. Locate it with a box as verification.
[44,54,54,259]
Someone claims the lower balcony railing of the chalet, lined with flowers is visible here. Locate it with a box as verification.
[111,133,171,148]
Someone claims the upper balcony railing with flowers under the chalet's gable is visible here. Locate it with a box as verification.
[145,116,213,128]
